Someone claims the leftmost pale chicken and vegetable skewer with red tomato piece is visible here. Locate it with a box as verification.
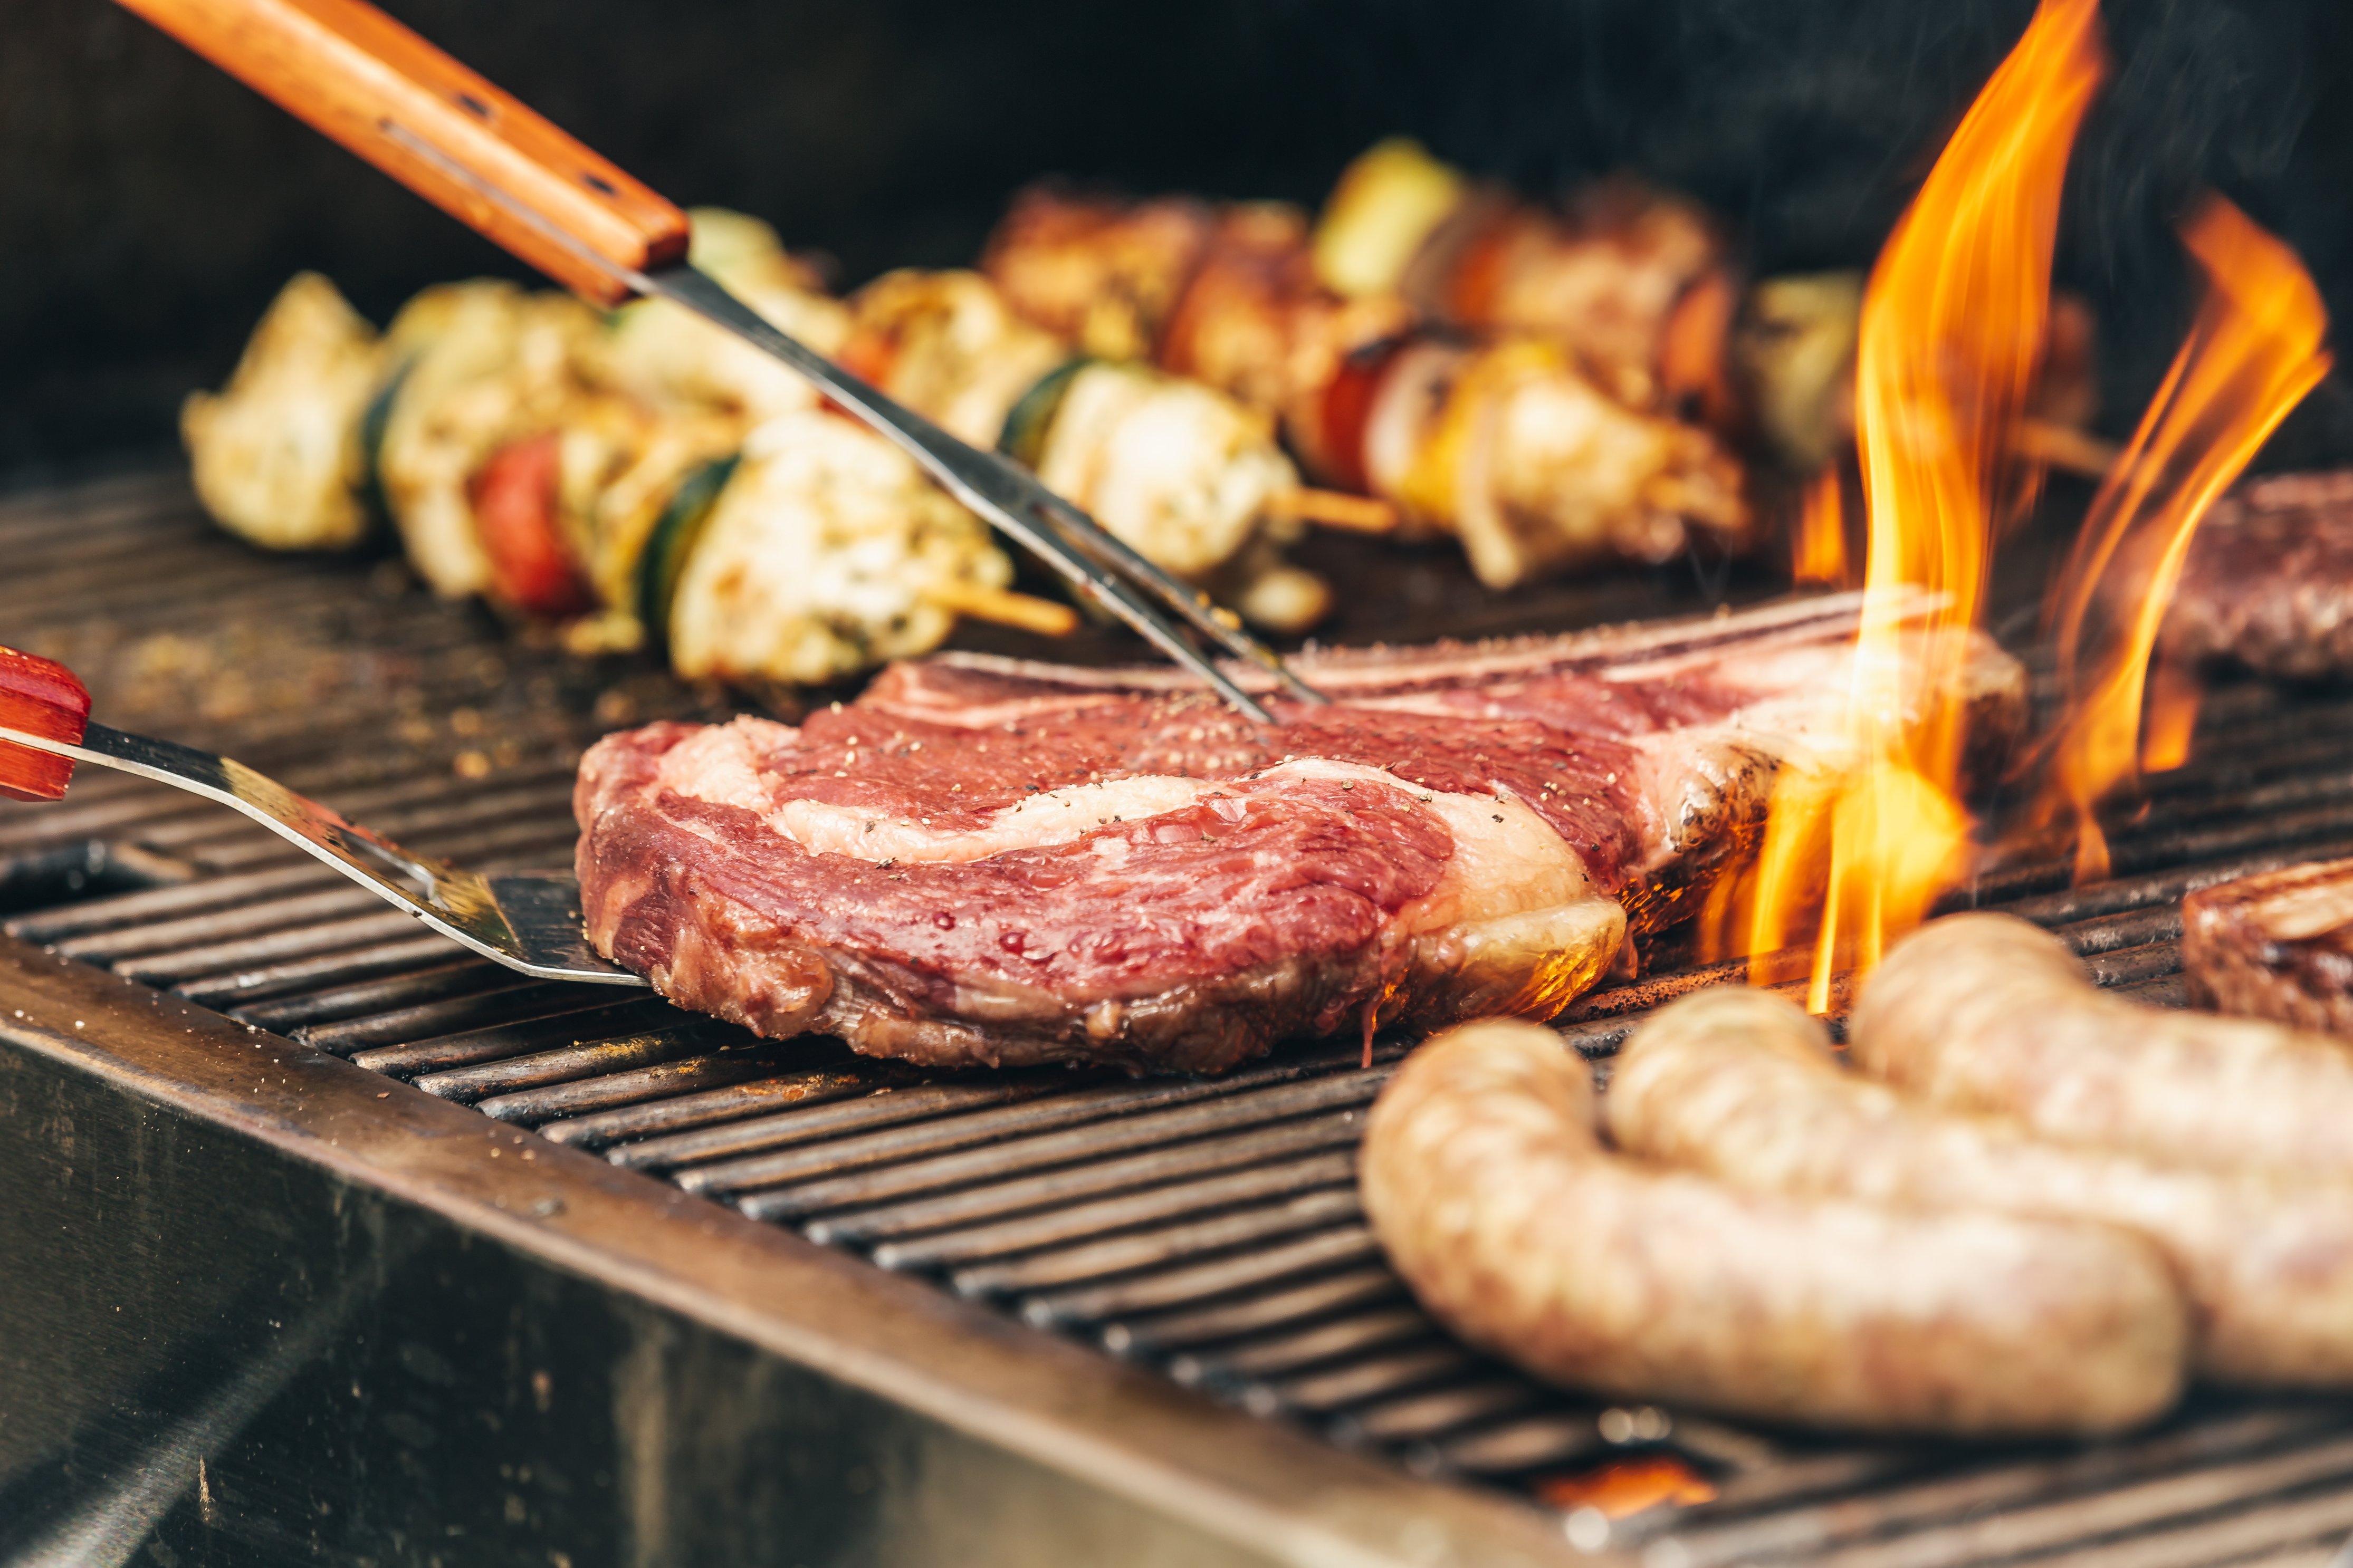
[184,252,1026,684]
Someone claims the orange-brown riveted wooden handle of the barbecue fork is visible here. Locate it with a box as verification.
[120,0,687,305]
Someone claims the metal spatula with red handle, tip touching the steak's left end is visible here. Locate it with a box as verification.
[0,649,645,985]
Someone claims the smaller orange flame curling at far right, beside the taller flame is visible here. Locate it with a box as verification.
[2038,197,2329,881]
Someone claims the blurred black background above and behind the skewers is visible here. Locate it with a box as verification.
[14,0,2353,482]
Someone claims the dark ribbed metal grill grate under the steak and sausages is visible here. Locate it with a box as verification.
[14,475,2353,1568]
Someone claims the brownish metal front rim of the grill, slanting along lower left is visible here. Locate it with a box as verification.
[0,940,1567,1568]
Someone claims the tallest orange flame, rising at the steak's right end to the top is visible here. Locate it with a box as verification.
[1751,0,2106,1013]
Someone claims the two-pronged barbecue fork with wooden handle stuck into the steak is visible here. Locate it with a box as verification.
[106,0,1325,724]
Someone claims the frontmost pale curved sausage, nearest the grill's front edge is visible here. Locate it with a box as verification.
[1360,1020,2188,1434]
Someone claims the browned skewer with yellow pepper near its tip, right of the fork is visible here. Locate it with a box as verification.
[983,169,1751,588]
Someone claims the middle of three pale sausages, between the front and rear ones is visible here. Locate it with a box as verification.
[1605,985,2353,1387]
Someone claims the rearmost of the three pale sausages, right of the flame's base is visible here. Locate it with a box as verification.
[1847,915,2353,1178]
